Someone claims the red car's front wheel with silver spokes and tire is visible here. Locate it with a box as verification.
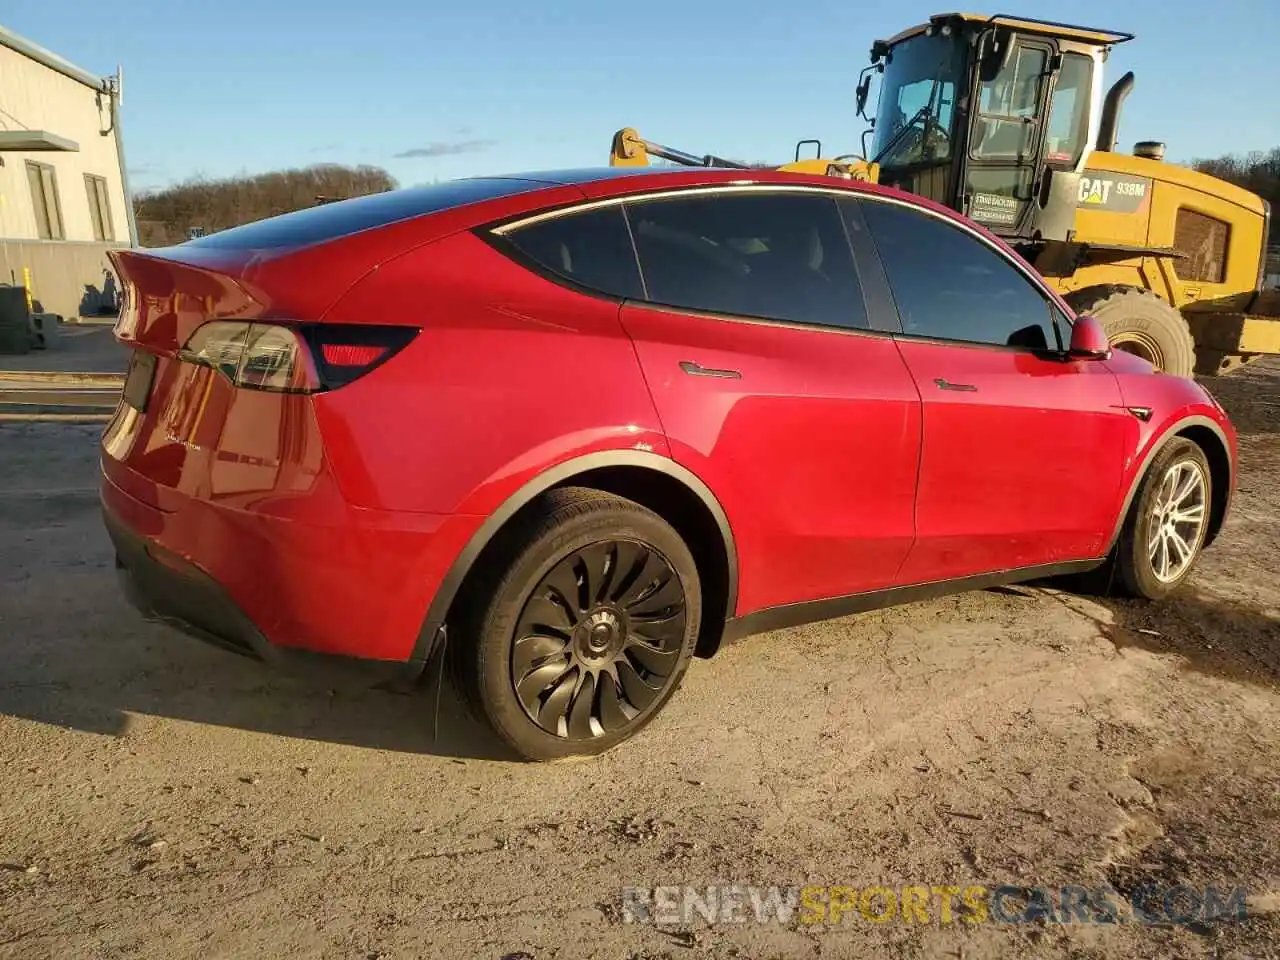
[1115,438,1213,600]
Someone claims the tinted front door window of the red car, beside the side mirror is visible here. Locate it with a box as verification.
[863,201,1061,351]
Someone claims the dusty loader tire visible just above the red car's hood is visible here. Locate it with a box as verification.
[1066,283,1196,378]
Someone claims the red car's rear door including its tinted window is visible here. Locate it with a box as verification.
[622,187,920,616]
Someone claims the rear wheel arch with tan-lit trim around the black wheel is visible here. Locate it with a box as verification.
[412,451,737,663]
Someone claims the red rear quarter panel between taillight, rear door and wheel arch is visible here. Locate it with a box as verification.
[316,232,668,516]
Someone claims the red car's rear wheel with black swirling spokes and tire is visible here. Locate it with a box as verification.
[454,488,701,760]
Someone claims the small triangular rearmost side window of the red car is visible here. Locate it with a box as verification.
[496,205,644,300]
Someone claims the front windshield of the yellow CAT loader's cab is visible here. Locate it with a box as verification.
[873,35,963,166]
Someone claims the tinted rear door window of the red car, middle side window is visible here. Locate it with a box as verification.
[627,192,868,328]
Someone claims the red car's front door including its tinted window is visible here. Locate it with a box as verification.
[852,197,1137,584]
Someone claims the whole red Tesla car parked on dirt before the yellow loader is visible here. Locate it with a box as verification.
[101,169,1235,759]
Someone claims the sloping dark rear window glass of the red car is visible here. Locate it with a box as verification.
[183,178,548,250]
